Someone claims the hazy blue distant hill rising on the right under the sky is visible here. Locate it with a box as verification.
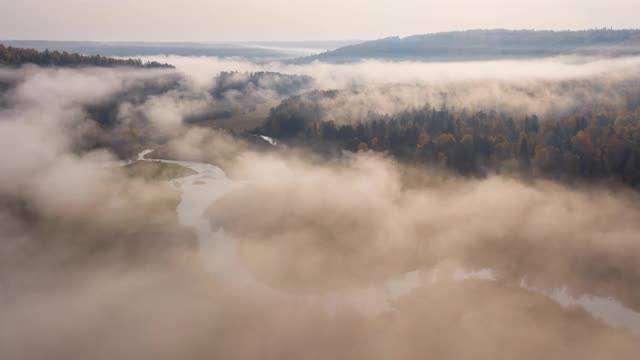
[297,29,640,63]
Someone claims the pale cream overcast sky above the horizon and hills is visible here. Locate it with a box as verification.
[0,0,640,41]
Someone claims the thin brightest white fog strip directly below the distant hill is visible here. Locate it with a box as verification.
[150,55,640,84]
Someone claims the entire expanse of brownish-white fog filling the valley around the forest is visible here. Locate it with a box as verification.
[0,57,640,359]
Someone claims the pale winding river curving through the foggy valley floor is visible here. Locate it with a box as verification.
[138,149,640,335]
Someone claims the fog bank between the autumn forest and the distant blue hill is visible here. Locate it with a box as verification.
[140,56,640,123]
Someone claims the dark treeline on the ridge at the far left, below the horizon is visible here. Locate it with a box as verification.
[0,44,173,68]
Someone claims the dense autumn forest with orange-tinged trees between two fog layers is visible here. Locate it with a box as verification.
[258,91,640,187]
